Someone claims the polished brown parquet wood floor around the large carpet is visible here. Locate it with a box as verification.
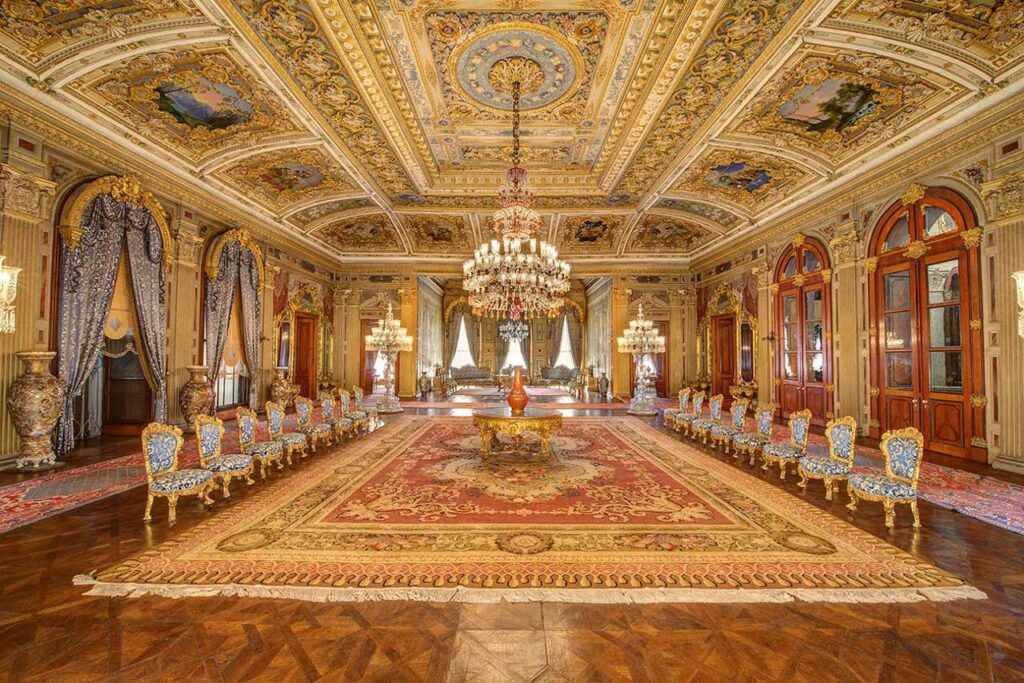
[0,409,1024,683]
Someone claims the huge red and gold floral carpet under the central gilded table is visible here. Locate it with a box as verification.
[76,416,984,602]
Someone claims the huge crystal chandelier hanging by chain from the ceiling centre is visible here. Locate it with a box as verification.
[463,69,569,321]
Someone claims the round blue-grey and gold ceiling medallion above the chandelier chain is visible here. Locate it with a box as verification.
[452,22,585,114]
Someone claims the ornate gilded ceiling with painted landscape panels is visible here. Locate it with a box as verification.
[0,0,1024,262]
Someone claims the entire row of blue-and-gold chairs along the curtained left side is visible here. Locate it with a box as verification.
[142,387,381,526]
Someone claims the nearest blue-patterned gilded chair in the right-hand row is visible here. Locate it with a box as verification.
[846,427,925,528]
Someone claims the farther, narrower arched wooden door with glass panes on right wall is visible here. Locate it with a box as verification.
[775,234,833,425]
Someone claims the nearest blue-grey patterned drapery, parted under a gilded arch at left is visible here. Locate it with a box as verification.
[56,195,167,456]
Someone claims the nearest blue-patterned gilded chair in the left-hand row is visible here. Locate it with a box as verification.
[142,422,213,526]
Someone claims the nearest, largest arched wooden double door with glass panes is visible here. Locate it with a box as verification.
[866,185,986,461]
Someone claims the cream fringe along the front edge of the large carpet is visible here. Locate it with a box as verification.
[73,574,988,604]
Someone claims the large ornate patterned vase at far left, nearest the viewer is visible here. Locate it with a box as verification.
[7,351,65,469]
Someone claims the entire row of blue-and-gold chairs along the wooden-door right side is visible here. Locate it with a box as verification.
[664,388,925,528]
